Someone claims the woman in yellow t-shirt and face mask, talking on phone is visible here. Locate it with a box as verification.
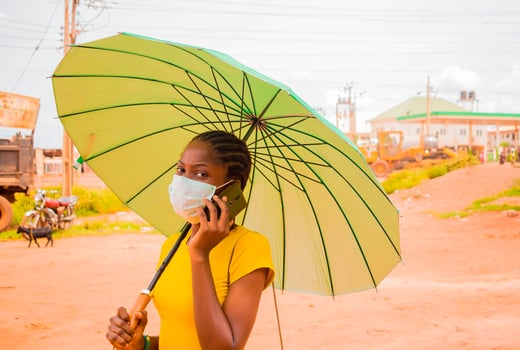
[106,131,274,350]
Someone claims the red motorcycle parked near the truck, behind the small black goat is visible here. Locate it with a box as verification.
[20,189,78,230]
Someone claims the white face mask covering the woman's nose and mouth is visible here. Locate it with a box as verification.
[168,175,217,224]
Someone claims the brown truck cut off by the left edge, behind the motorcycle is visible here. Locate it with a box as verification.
[0,92,40,232]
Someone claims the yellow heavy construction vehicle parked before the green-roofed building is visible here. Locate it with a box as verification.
[358,130,456,177]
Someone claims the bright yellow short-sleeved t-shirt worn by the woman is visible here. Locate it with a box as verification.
[153,226,274,350]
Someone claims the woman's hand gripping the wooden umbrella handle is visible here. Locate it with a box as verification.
[106,306,148,350]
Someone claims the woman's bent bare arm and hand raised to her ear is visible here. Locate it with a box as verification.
[189,196,268,350]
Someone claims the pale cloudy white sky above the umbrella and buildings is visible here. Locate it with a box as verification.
[0,0,520,148]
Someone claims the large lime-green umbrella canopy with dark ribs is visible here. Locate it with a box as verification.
[52,34,401,295]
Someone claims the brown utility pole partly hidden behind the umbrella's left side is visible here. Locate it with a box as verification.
[61,0,79,196]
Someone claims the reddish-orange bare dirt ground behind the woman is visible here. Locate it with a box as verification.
[0,164,520,350]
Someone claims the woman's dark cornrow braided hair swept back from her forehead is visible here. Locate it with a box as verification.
[192,130,251,189]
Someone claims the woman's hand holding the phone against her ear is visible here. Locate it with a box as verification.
[189,196,232,255]
